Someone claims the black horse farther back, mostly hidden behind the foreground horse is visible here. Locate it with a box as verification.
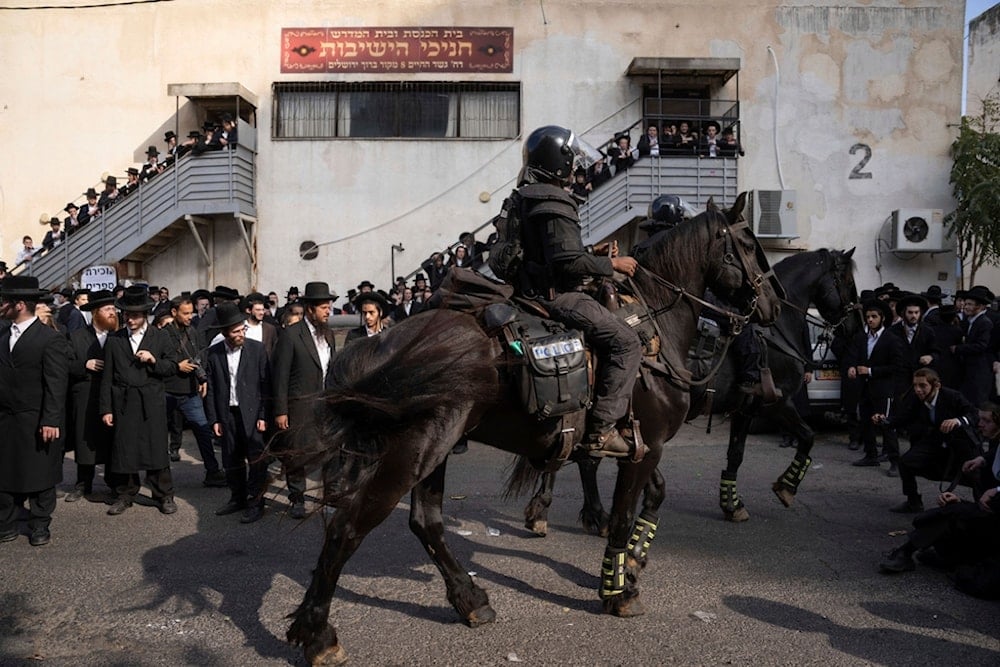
[524,248,860,535]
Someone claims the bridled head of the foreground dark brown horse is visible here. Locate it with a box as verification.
[692,193,784,325]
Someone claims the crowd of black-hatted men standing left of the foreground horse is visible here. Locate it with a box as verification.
[0,275,427,546]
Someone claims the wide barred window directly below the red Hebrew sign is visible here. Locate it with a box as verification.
[271,81,521,139]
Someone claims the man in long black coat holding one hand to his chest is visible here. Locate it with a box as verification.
[99,286,177,516]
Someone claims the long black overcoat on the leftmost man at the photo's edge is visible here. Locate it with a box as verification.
[0,320,69,493]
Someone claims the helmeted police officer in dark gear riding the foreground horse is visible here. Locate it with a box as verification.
[515,125,642,457]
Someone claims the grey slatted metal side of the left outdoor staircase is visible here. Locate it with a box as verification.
[20,142,257,288]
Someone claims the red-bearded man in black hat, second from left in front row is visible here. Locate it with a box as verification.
[65,290,118,503]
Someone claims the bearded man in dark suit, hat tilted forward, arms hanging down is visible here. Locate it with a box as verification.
[205,302,271,523]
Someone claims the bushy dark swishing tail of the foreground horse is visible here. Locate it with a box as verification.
[291,310,498,496]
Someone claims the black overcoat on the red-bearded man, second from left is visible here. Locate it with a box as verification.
[66,325,113,465]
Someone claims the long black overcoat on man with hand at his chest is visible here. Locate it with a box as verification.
[100,326,177,473]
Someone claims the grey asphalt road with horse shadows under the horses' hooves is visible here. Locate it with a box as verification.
[0,424,1000,667]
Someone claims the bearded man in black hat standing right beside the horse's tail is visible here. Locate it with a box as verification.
[273,282,337,519]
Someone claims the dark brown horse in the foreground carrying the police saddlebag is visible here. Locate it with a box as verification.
[287,195,779,665]
